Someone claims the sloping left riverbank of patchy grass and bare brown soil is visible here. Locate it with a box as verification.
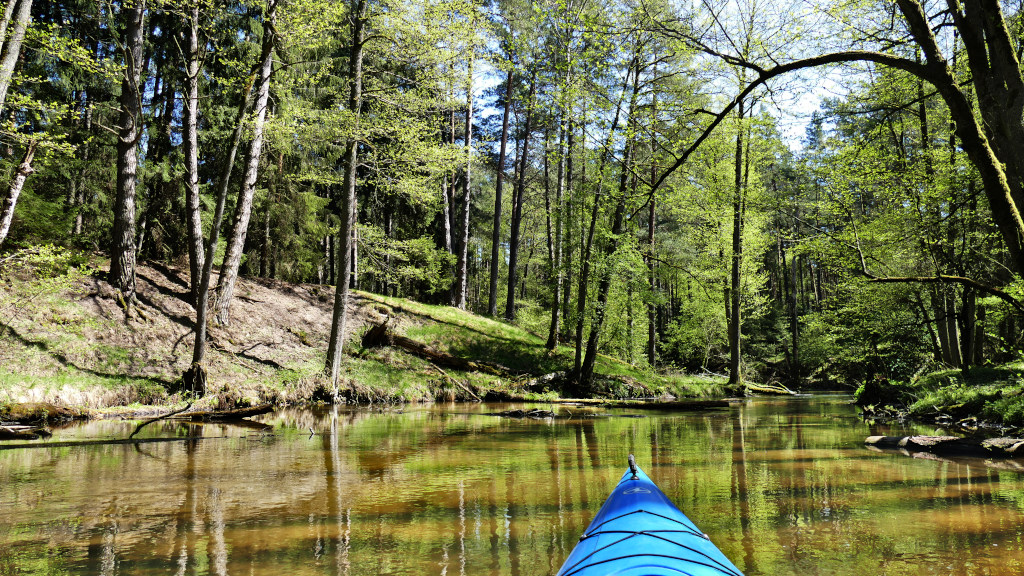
[0,248,725,413]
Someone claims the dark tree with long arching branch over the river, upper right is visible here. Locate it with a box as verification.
[655,0,1024,272]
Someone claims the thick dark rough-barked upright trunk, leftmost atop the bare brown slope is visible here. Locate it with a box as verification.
[110,0,145,306]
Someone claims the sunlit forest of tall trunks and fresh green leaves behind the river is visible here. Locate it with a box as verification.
[0,0,1024,403]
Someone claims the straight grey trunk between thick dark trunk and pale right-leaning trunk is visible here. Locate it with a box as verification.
[182,0,205,306]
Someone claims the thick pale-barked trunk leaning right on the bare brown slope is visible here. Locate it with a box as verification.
[216,0,278,326]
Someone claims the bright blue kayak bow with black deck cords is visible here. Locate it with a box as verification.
[558,454,742,576]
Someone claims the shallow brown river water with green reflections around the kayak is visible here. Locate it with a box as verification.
[0,397,1024,575]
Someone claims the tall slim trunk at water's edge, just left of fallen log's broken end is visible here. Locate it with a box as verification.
[327,0,366,387]
